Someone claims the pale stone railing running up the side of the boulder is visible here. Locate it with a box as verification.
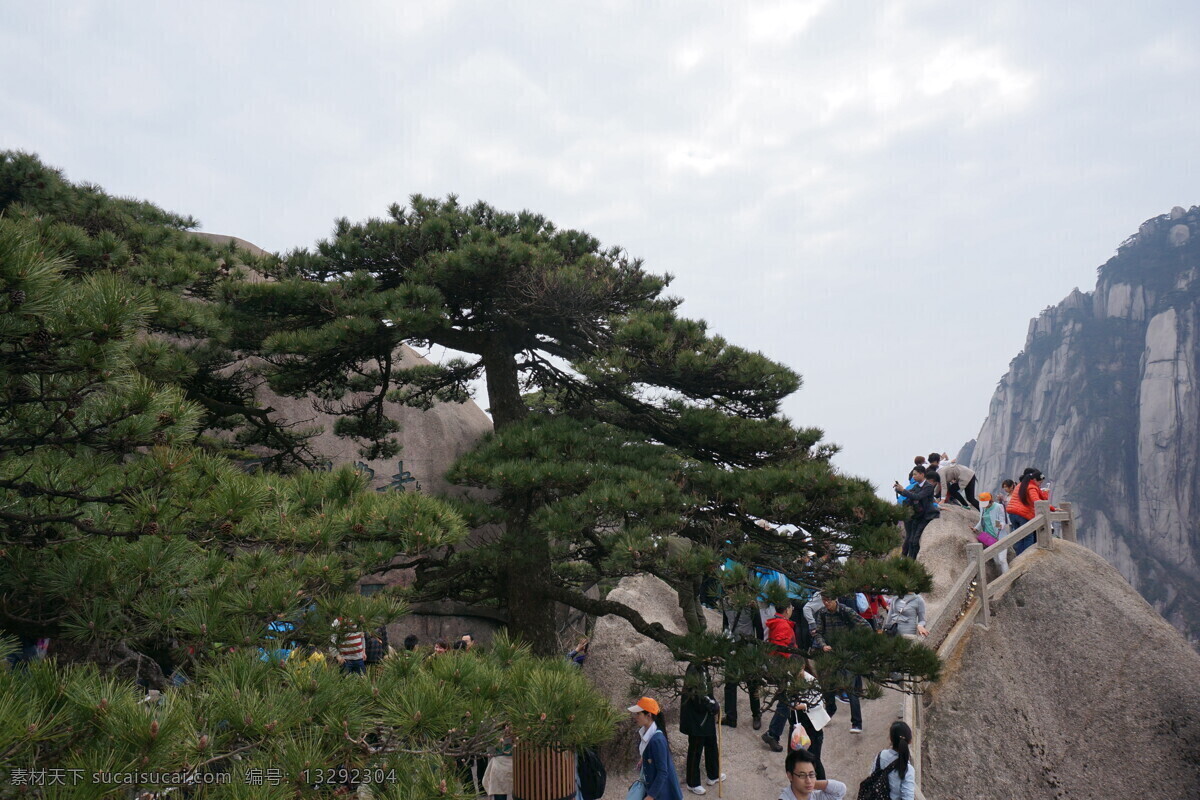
[902,500,1076,800]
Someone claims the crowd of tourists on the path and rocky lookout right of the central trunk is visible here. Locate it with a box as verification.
[628,452,1052,800]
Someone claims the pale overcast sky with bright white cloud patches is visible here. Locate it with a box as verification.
[0,0,1200,488]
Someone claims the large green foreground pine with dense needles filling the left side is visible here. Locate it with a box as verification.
[0,165,613,799]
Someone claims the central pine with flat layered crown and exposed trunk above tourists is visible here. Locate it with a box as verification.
[223,196,936,695]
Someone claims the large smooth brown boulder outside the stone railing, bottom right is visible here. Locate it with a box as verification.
[923,541,1200,800]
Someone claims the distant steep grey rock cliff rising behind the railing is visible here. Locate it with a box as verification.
[960,206,1200,644]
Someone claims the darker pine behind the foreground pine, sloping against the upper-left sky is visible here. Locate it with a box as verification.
[0,151,318,469]
